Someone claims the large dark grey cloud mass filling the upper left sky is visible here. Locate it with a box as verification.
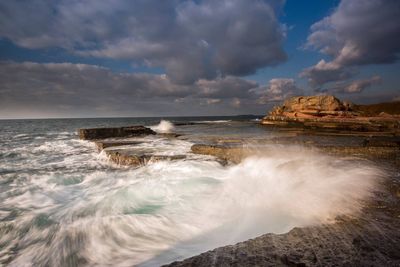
[0,0,286,84]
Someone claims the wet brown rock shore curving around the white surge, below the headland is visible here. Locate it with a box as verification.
[78,120,400,266]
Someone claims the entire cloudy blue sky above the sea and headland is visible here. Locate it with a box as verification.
[0,0,400,119]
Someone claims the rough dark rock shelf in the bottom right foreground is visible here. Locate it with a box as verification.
[166,207,400,266]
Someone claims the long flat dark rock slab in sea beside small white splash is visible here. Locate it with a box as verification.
[78,126,156,140]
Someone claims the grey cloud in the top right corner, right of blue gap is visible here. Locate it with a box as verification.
[301,0,400,86]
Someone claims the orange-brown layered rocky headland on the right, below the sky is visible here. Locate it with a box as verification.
[261,95,400,134]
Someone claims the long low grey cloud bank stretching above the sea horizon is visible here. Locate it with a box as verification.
[0,62,258,116]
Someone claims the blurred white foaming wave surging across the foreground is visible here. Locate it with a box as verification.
[0,140,380,266]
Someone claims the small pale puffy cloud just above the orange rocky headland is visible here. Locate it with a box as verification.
[257,78,303,104]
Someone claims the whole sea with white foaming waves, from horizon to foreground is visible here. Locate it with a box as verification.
[0,116,384,267]
